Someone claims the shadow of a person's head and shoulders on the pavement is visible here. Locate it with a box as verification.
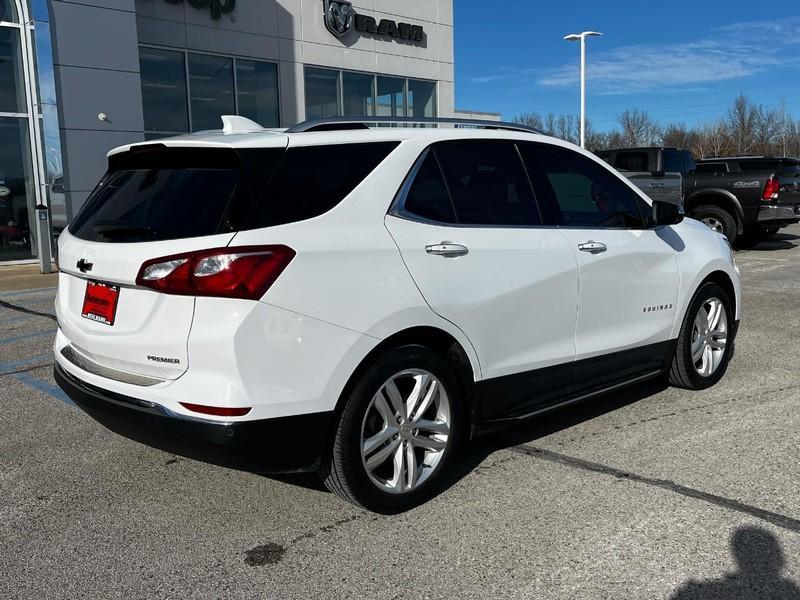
[670,527,800,600]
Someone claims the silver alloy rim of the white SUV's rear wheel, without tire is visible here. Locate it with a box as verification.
[360,369,451,494]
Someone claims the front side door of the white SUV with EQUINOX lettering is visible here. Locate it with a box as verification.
[521,143,682,394]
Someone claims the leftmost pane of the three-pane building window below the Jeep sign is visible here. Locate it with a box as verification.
[139,47,189,133]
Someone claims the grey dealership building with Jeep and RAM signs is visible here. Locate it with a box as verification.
[0,0,485,263]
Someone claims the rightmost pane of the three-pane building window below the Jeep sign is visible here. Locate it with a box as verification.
[236,58,280,127]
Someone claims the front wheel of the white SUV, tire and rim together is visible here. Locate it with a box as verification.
[668,282,736,390]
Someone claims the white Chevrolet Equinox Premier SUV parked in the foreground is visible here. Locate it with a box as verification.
[55,117,741,511]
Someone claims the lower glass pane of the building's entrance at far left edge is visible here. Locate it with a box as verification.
[0,117,34,261]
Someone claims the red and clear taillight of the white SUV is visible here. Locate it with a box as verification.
[136,246,295,300]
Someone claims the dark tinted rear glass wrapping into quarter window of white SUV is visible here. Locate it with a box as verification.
[69,142,397,243]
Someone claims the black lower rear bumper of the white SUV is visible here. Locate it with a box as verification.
[54,364,333,473]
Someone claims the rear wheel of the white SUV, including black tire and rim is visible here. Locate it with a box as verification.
[320,345,464,513]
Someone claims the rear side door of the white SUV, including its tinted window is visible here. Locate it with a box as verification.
[386,140,578,419]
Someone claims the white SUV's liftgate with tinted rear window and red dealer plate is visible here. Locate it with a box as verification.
[57,144,283,379]
